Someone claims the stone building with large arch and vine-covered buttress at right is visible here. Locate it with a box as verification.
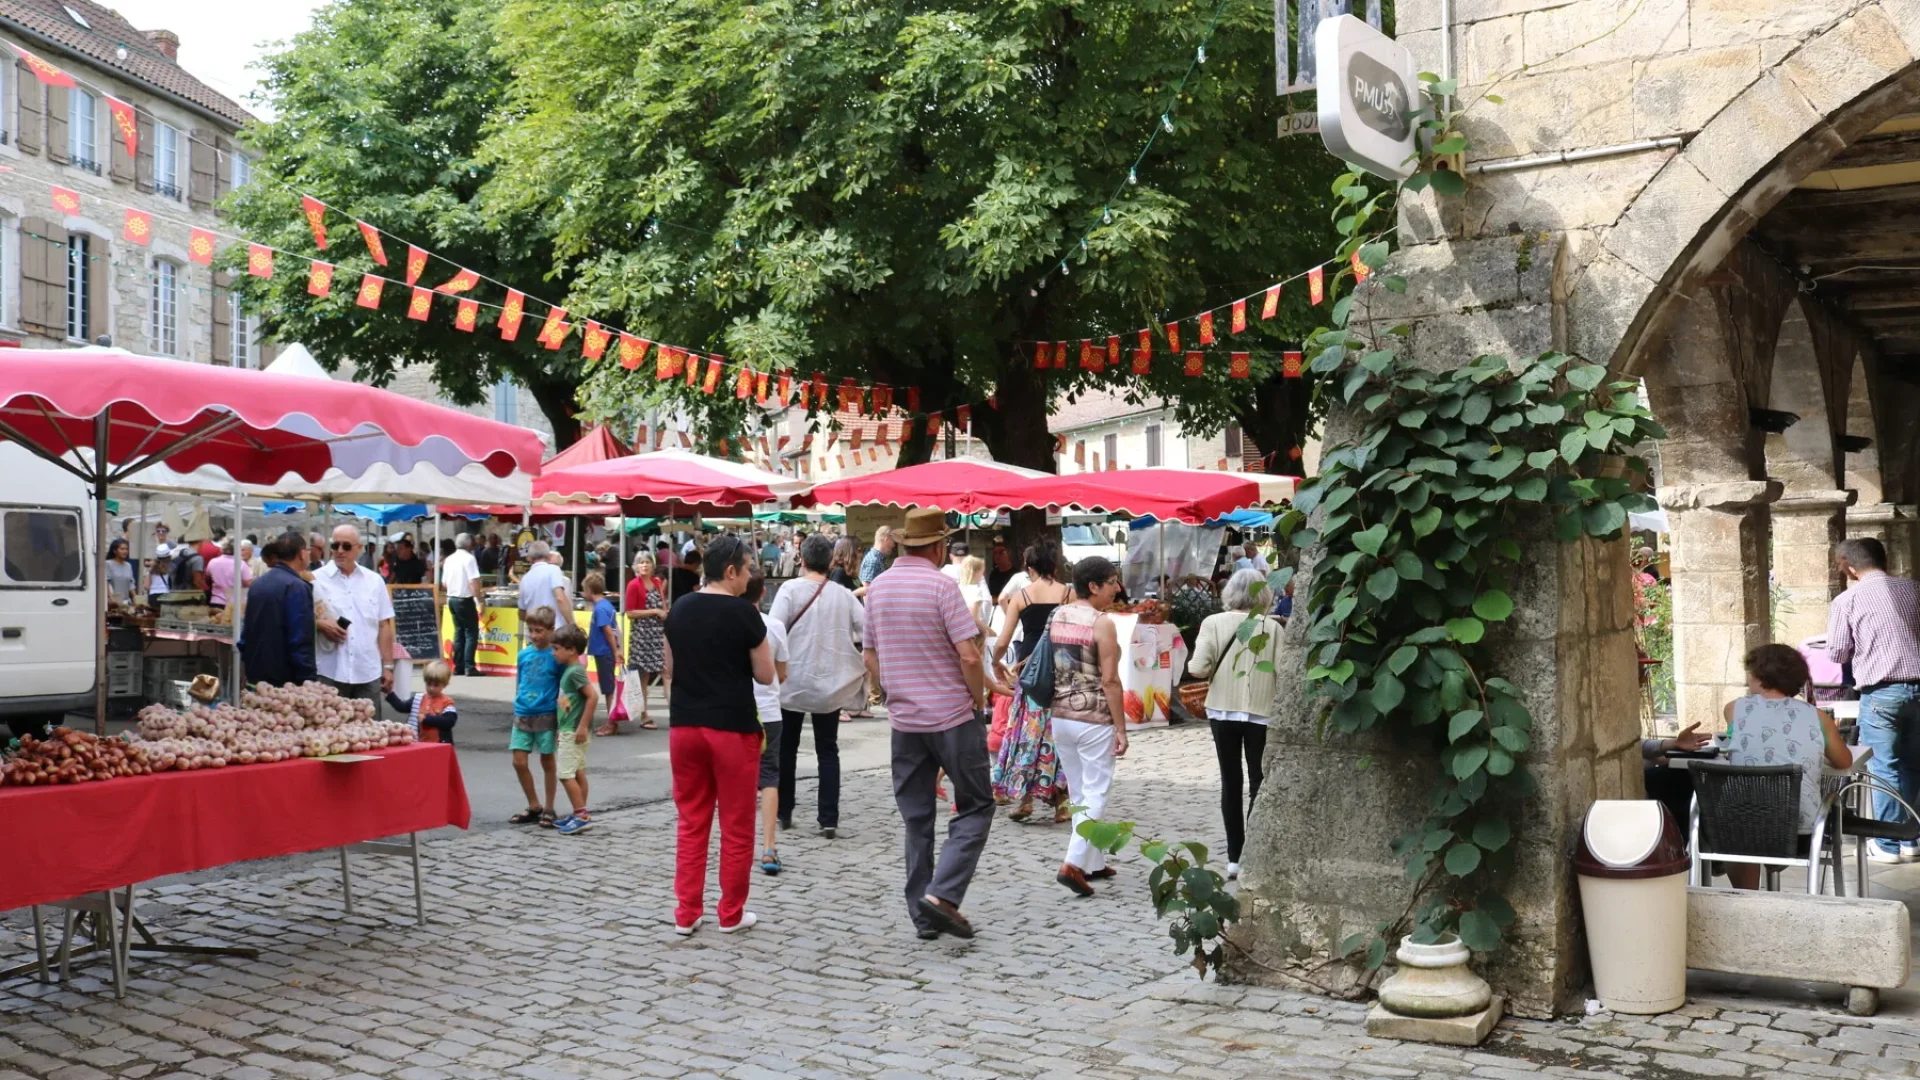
[1238,0,1920,1015]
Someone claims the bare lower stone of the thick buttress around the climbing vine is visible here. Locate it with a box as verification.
[1229,523,1642,1017]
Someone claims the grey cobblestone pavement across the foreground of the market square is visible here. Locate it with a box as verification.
[0,730,1920,1080]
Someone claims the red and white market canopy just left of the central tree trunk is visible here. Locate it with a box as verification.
[534,450,806,517]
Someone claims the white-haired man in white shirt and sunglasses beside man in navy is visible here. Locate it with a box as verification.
[313,525,394,717]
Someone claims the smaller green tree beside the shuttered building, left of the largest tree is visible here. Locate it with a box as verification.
[225,0,582,446]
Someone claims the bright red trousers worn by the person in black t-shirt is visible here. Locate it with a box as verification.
[666,726,762,926]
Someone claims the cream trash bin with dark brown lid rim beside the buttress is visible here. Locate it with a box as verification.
[1572,799,1688,1015]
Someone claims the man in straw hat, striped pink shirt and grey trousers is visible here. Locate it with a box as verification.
[864,509,993,940]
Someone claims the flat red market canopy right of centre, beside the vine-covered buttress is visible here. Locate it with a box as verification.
[977,469,1298,525]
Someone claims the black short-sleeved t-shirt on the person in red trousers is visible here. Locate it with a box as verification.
[666,592,766,732]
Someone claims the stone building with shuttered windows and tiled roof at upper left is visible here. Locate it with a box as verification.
[0,0,255,367]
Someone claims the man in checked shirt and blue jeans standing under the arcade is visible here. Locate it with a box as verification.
[1826,538,1920,863]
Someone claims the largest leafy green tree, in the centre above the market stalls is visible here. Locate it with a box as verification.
[482,0,1338,469]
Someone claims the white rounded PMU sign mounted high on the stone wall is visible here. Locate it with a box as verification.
[1313,15,1419,181]
